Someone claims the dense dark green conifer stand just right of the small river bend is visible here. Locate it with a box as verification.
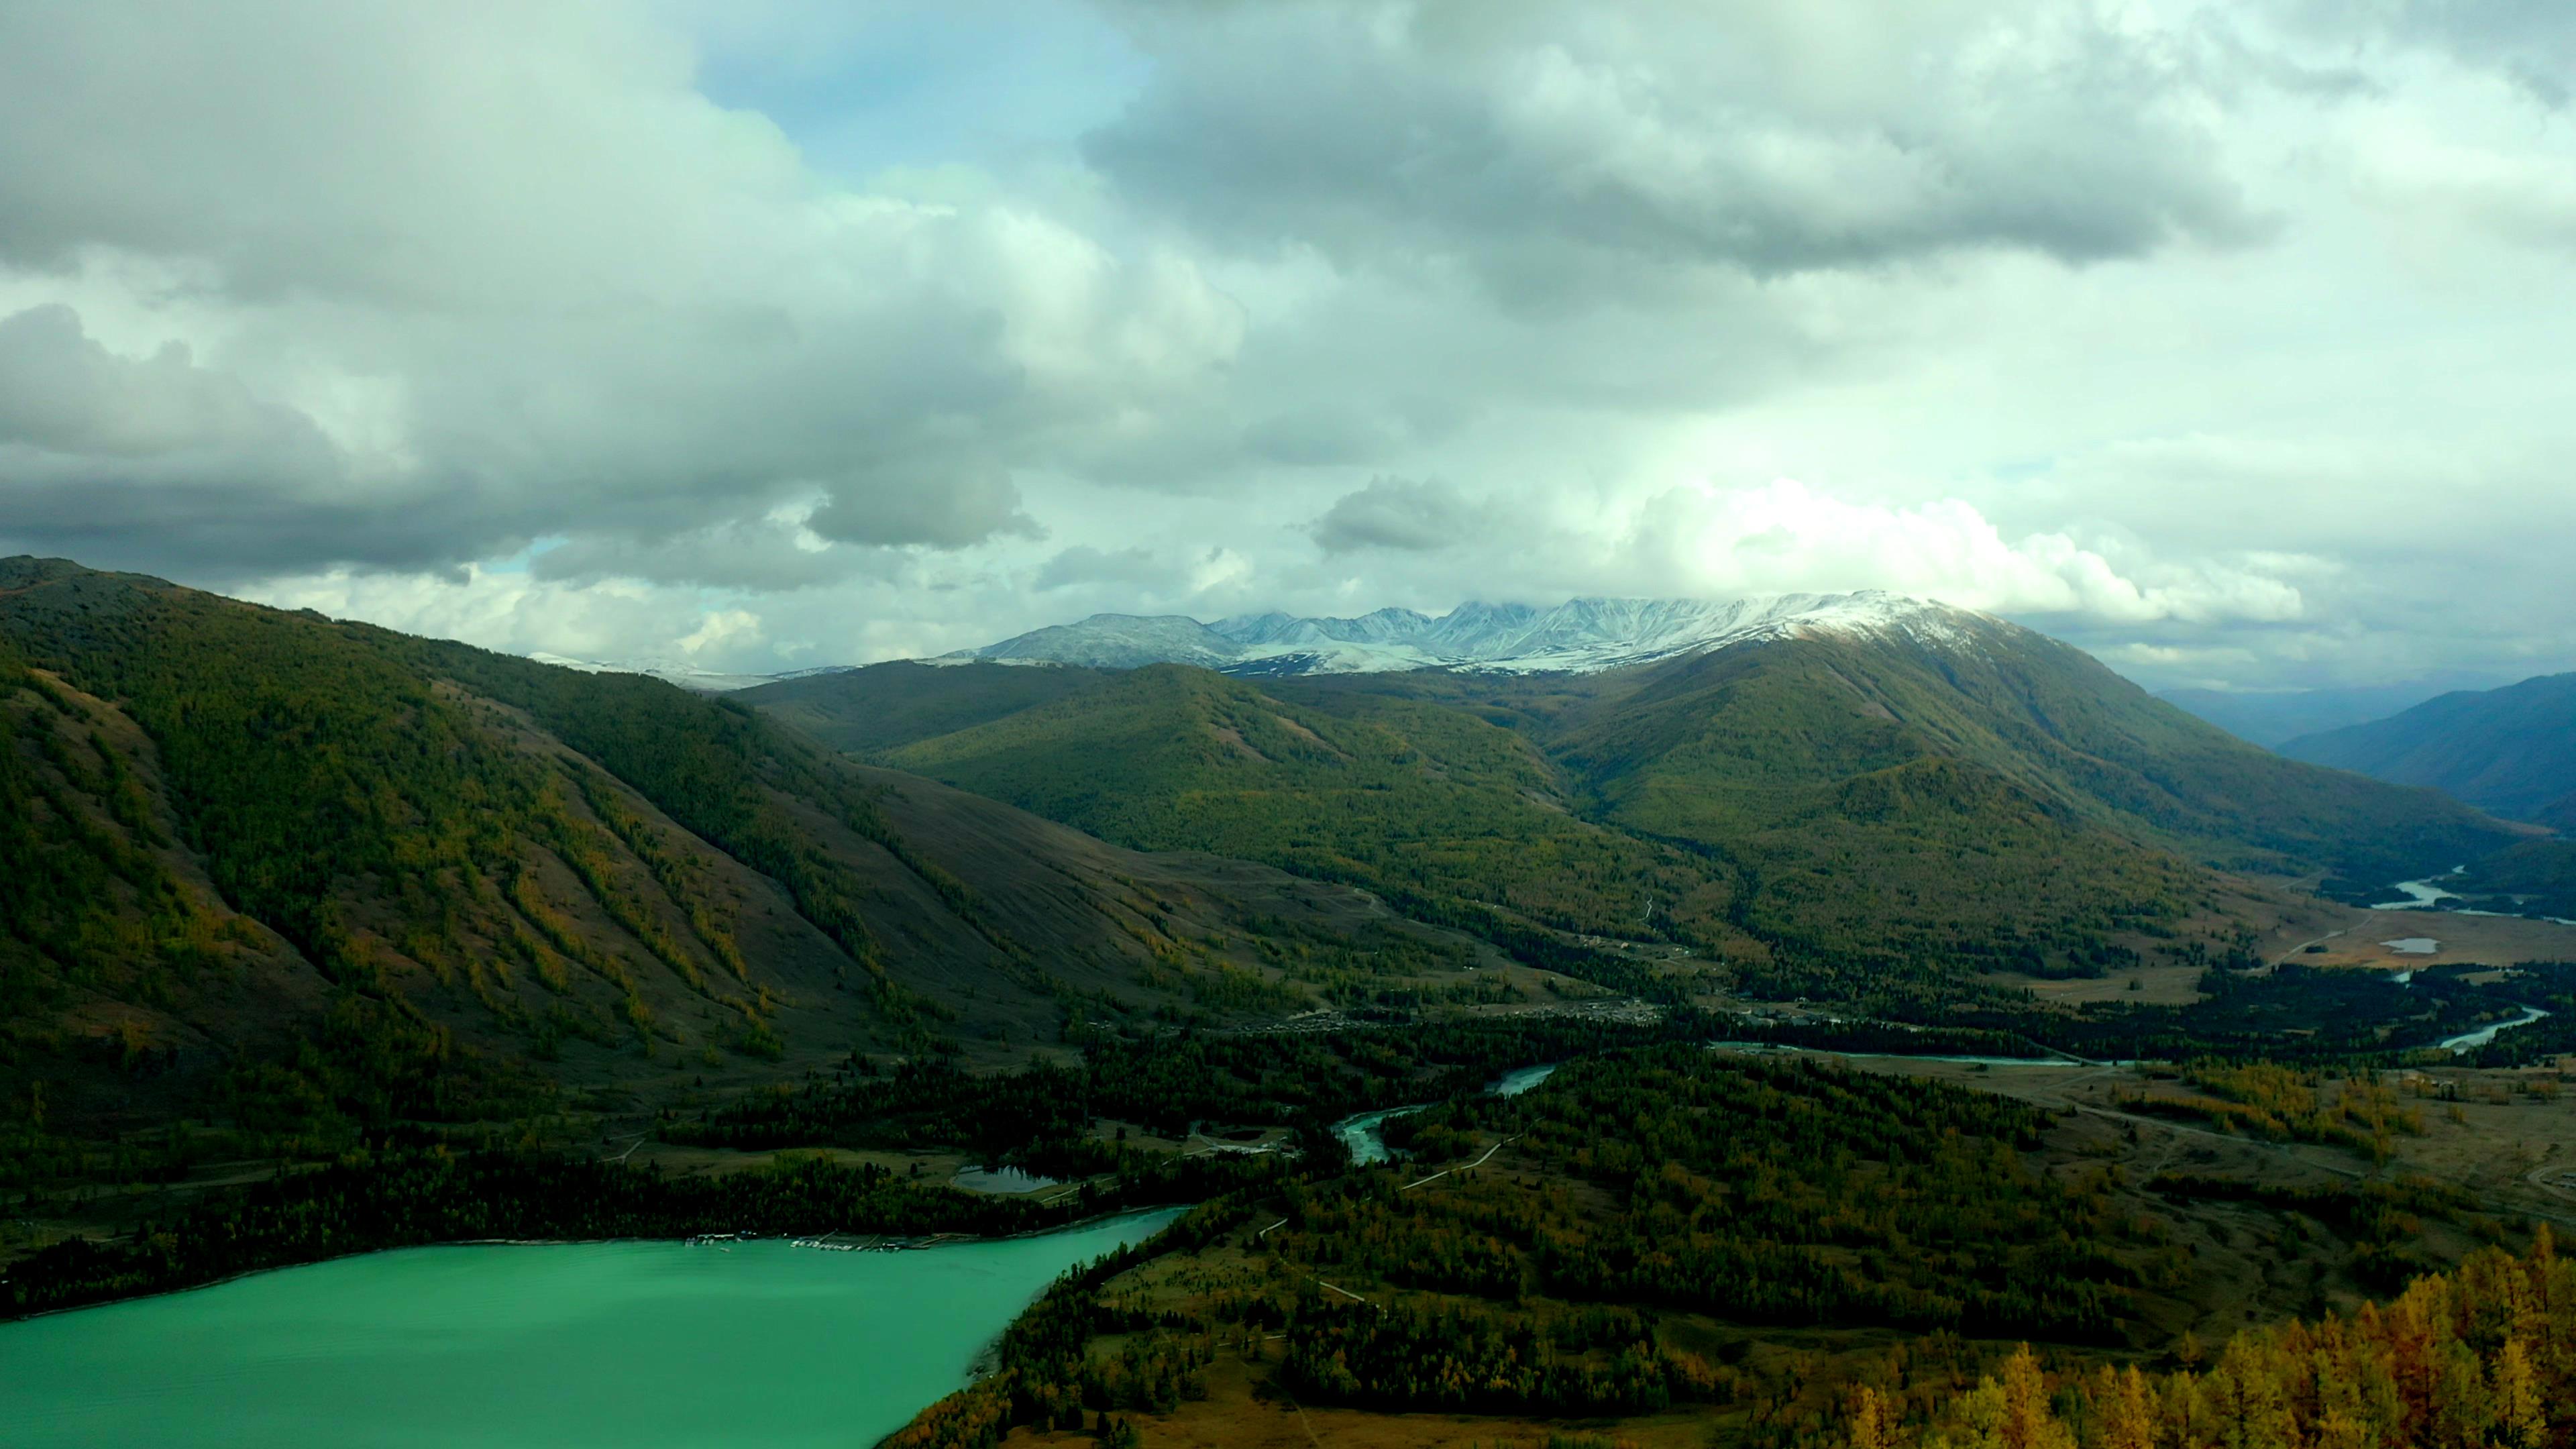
[1273,1046,2141,1341]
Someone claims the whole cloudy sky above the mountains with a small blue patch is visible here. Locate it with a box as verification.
[0,0,2576,688]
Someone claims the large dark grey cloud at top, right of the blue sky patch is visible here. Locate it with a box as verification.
[1085,0,2262,299]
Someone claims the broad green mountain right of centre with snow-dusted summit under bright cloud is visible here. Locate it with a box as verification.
[1548,621,2512,954]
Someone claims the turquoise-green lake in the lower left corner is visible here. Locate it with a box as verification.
[0,1210,1180,1449]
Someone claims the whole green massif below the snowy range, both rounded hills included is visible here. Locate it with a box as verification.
[855,598,2514,990]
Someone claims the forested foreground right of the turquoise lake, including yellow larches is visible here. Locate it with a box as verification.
[875,1044,2571,1449]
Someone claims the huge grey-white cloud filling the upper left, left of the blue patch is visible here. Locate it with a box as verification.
[0,0,1242,578]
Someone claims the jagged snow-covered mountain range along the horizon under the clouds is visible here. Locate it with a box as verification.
[932,590,1978,676]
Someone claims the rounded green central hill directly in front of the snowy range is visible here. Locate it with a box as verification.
[883,665,1747,974]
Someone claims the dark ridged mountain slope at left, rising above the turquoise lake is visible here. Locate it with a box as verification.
[0,559,1494,1168]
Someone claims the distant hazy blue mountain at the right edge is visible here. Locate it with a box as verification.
[2279,673,2576,828]
